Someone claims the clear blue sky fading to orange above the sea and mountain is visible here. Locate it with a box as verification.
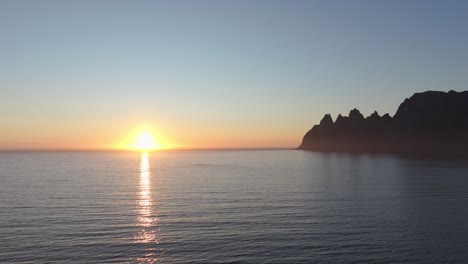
[0,0,468,149]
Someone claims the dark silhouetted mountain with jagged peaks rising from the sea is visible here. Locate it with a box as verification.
[299,91,468,155]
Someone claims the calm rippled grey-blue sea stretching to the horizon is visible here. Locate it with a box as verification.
[0,150,468,263]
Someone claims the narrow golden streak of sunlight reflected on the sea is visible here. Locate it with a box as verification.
[135,152,159,263]
